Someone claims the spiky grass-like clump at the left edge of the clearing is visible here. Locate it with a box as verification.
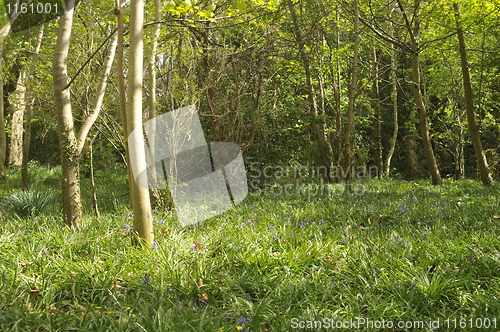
[3,190,54,218]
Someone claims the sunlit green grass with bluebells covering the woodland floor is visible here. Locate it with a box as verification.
[0,165,500,332]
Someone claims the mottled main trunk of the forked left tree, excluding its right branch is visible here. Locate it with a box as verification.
[52,0,82,229]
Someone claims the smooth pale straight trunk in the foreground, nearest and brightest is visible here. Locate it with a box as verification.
[127,0,154,246]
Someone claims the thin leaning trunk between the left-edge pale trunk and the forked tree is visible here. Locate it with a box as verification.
[21,23,45,190]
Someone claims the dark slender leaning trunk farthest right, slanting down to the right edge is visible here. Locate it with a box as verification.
[453,3,493,185]
